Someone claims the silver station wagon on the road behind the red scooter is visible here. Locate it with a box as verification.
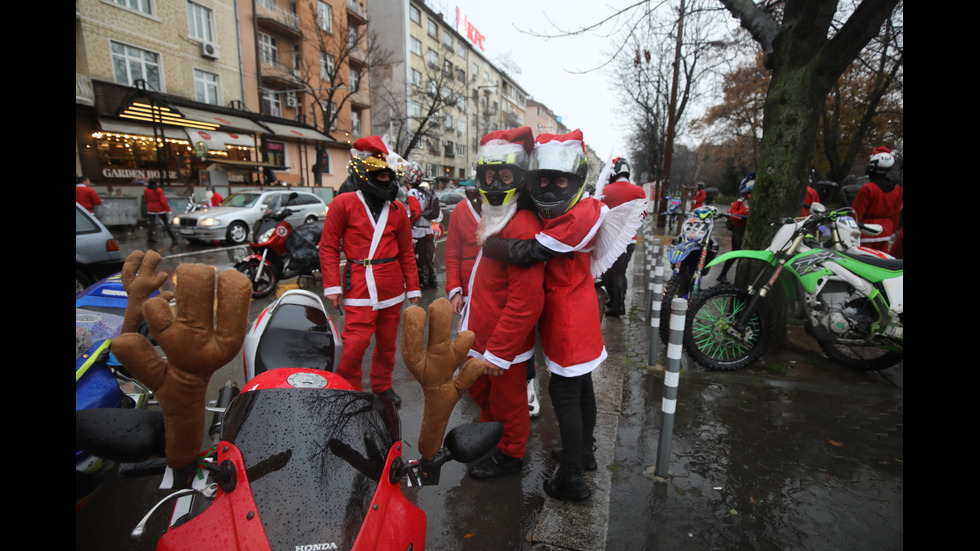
[173,190,327,245]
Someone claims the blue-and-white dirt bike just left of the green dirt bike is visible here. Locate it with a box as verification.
[660,206,728,344]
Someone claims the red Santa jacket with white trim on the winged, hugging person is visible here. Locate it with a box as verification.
[535,197,608,377]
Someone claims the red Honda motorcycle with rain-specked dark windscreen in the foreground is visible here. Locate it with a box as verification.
[76,293,503,551]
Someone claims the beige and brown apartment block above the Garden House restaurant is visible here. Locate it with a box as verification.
[75,0,370,194]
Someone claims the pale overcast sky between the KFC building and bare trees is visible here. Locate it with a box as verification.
[444,0,635,160]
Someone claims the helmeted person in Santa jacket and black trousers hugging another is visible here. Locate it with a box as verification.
[483,130,612,501]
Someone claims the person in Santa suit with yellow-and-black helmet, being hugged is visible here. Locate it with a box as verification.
[456,126,544,480]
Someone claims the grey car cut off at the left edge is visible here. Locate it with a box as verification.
[75,203,123,295]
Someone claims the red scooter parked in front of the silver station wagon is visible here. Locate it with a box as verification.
[235,208,323,298]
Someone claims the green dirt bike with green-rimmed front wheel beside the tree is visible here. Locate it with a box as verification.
[684,203,904,371]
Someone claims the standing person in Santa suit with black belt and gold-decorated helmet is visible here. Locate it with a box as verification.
[320,136,422,405]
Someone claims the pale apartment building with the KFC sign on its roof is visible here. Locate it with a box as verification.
[369,0,527,185]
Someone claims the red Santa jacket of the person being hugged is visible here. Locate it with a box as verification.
[454,209,544,369]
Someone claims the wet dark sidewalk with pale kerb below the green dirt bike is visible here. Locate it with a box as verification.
[531,226,904,551]
